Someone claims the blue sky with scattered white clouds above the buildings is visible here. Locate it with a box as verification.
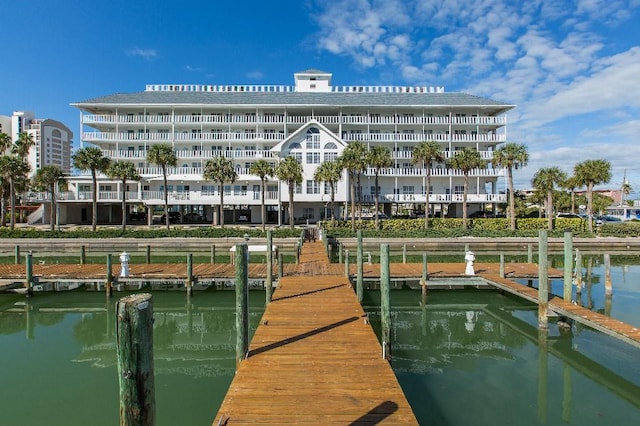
[0,0,640,191]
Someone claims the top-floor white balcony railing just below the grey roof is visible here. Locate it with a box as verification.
[82,113,507,127]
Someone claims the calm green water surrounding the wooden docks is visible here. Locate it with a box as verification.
[0,261,640,425]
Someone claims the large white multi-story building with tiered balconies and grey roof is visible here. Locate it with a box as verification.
[56,70,514,224]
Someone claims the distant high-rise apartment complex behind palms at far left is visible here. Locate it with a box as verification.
[0,111,73,176]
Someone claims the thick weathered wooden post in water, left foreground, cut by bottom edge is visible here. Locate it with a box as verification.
[116,293,156,426]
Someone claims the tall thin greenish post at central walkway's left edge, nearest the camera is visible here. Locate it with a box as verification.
[235,244,249,370]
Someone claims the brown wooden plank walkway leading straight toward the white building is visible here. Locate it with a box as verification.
[213,243,418,425]
